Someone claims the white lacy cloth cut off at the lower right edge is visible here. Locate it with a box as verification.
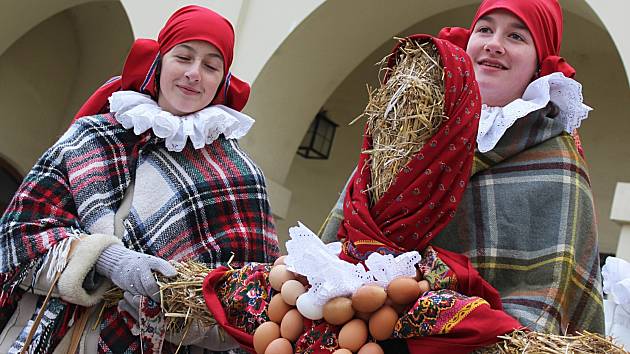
[602,257,630,348]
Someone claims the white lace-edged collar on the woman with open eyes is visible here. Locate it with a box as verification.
[477,72,592,152]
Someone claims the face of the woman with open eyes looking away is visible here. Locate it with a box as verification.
[466,10,538,107]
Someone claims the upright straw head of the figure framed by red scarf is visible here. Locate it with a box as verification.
[353,40,447,203]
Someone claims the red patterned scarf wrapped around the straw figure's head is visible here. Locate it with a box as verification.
[339,35,481,262]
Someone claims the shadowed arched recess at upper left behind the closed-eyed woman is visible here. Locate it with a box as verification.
[0,1,133,171]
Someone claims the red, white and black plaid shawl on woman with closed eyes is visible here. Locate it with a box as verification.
[0,114,278,352]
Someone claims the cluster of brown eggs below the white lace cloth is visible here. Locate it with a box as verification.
[254,256,429,354]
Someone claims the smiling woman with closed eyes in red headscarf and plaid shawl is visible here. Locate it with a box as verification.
[0,6,278,353]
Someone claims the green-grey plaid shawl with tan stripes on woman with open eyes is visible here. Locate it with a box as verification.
[320,109,604,333]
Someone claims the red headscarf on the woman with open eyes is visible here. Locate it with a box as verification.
[439,0,575,78]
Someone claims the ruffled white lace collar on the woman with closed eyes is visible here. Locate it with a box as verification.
[109,91,254,152]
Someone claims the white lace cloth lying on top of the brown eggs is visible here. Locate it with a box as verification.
[284,222,420,316]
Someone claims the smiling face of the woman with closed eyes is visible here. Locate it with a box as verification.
[158,41,224,116]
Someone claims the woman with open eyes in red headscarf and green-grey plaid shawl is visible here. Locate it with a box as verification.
[435,0,604,333]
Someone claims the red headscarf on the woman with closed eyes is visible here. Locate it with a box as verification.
[74,5,250,120]
